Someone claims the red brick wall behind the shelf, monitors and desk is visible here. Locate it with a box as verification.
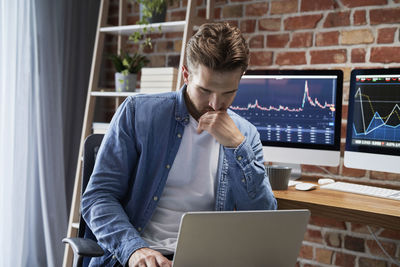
[102,0,400,267]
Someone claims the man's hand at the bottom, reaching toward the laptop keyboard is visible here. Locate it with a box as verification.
[129,248,172,267]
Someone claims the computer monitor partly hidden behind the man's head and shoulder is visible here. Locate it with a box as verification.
[230,70,343,166]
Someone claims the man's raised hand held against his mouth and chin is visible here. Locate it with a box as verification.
[197,110,244,148]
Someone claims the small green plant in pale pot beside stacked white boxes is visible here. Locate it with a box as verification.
[110,52,149,92]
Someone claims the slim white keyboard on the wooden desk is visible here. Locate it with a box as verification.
[320,182,400,201]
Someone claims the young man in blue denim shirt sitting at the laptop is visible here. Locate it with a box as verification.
[82,23,276,267]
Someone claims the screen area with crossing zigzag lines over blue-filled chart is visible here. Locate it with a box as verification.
[351,75,400,148]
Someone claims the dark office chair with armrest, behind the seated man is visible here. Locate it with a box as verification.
[62,134,104,267]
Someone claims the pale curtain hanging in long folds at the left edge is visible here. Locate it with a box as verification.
[0,0,67,267]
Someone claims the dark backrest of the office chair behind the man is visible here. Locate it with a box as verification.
[78,134,104,266]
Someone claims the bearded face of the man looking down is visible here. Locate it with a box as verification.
[183,64,243,119]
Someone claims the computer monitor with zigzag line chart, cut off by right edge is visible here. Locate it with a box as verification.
[344,69,400,173]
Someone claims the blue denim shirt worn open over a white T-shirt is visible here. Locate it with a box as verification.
[81,86,276,266]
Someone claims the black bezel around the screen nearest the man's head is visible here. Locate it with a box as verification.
[244,69,343,151]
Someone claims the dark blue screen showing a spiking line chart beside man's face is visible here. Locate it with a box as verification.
[230,75,337,145]
